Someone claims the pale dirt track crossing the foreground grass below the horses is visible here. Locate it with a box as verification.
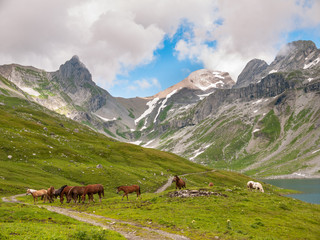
[2,194,189,240]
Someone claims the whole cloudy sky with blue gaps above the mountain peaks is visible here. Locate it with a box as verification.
[0,0,320,98]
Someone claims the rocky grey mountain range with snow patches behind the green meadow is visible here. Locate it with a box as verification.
[0,41,320,177]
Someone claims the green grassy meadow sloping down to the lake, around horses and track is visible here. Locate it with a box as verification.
[0,95,320,239]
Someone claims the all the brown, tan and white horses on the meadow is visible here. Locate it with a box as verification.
[27,175,264,204]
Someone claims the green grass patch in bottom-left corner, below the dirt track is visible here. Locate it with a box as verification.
[0,202,125,240]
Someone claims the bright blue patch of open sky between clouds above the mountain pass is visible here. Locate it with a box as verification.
[109,24,204,97]
